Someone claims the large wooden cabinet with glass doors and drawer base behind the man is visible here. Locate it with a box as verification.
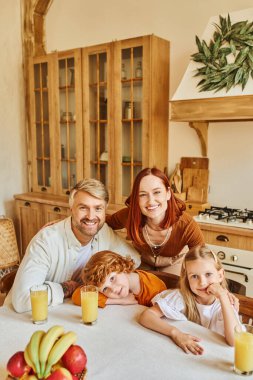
[15,35,169,255]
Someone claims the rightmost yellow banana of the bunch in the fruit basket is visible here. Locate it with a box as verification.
[44,331,77,377]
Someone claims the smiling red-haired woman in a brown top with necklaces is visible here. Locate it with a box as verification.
[106,168,204,274]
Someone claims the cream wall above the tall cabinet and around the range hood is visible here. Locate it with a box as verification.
[46,0,253,209]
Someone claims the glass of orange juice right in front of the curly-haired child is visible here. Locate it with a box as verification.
[81,285,98,325]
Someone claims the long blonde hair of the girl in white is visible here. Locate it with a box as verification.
[180,245,227,324]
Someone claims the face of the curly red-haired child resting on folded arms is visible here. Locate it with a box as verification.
[99,272,129,298]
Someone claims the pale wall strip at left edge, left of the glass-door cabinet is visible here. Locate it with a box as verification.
[0,0,27,217]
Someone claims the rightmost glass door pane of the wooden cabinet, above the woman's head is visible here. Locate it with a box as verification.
[121,46,143,198]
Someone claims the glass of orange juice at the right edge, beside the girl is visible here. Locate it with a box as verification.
[234,324,253,376]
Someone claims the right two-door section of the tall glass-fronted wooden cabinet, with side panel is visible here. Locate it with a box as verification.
[82,35,169,204]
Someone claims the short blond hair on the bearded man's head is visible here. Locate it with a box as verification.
[69,178,109,207]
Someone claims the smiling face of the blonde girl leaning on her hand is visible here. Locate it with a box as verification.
[186,258,224,303]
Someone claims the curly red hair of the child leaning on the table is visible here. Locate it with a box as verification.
[82,251,135,287]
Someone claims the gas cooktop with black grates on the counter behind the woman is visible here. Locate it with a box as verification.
[194,206,253,230]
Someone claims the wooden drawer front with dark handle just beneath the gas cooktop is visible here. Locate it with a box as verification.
[199,223,253,251]
